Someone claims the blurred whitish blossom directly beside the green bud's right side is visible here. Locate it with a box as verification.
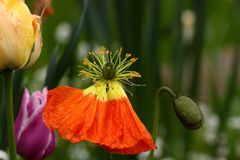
[202,104,220,145]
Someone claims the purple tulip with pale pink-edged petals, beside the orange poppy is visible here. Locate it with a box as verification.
[15,88,55,160]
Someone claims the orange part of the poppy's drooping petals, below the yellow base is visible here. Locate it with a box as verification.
[43,87,156,154]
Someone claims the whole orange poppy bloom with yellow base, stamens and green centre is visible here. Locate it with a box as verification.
[43,48,156,154]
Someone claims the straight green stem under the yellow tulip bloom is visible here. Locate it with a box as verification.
[3,70,16,160]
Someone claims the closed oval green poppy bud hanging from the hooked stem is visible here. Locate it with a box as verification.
[173,96,203,129]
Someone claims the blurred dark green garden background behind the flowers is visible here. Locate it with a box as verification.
[0,0,240,160]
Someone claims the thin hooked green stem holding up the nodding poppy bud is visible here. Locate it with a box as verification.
[149,87,177,160]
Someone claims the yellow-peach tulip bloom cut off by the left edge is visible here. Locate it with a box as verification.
[0,0,42,71]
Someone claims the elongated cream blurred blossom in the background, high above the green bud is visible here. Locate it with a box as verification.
[181,10,196,44]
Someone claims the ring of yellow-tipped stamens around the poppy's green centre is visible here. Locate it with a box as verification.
[79,47,141,85]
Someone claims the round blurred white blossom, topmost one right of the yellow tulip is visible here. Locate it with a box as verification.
[55,22,72,44]
